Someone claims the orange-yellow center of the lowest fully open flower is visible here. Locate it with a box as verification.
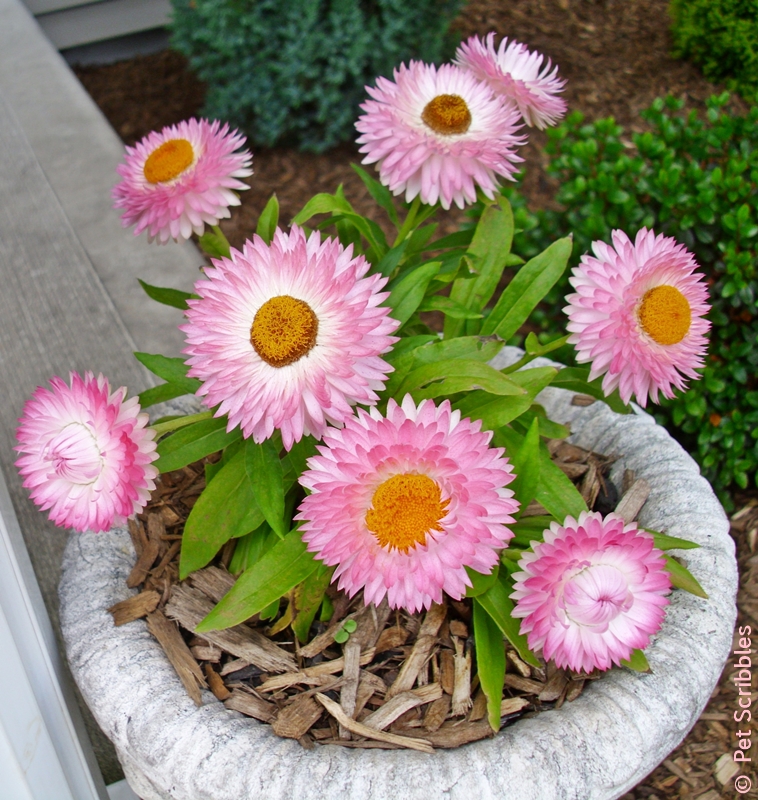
[366,472,450,553]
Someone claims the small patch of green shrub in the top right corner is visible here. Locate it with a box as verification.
[670,0,758,94]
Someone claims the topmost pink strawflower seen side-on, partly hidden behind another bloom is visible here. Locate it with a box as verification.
[455,33,566,129]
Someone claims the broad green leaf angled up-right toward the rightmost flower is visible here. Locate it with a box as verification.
[482,237,572,341]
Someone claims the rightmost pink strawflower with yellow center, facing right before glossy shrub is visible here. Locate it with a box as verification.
[563,228,710,407]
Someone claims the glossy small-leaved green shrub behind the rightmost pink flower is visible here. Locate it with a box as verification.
[498,94,758,500]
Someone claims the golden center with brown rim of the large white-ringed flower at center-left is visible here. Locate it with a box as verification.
[250,294,318,367]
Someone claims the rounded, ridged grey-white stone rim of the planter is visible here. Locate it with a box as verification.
[59,348,737,800]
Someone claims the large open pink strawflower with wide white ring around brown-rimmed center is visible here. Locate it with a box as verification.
[180,225,398,450]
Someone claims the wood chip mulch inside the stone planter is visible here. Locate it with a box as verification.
[110,396,664,752]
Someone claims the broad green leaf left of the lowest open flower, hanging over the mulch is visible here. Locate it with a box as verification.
[179,449,265,579]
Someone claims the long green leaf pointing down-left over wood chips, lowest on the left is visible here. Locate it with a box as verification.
[196,532,318,633]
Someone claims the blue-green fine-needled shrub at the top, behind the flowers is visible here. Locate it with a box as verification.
[171,0,463,152]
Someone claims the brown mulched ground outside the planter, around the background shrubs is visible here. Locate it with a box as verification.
[75,0,758,800]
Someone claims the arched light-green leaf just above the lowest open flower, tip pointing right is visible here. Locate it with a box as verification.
[397,359,526,402]
